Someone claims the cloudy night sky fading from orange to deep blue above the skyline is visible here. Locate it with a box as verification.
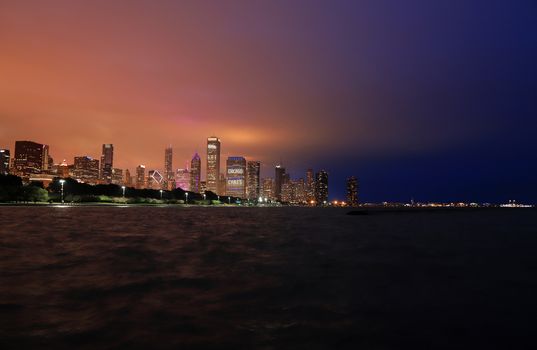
[0,0,537,202]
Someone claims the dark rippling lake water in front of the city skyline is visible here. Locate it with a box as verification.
[0,206,537,349]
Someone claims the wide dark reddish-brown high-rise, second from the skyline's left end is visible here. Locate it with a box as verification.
[13,141,49,177]
